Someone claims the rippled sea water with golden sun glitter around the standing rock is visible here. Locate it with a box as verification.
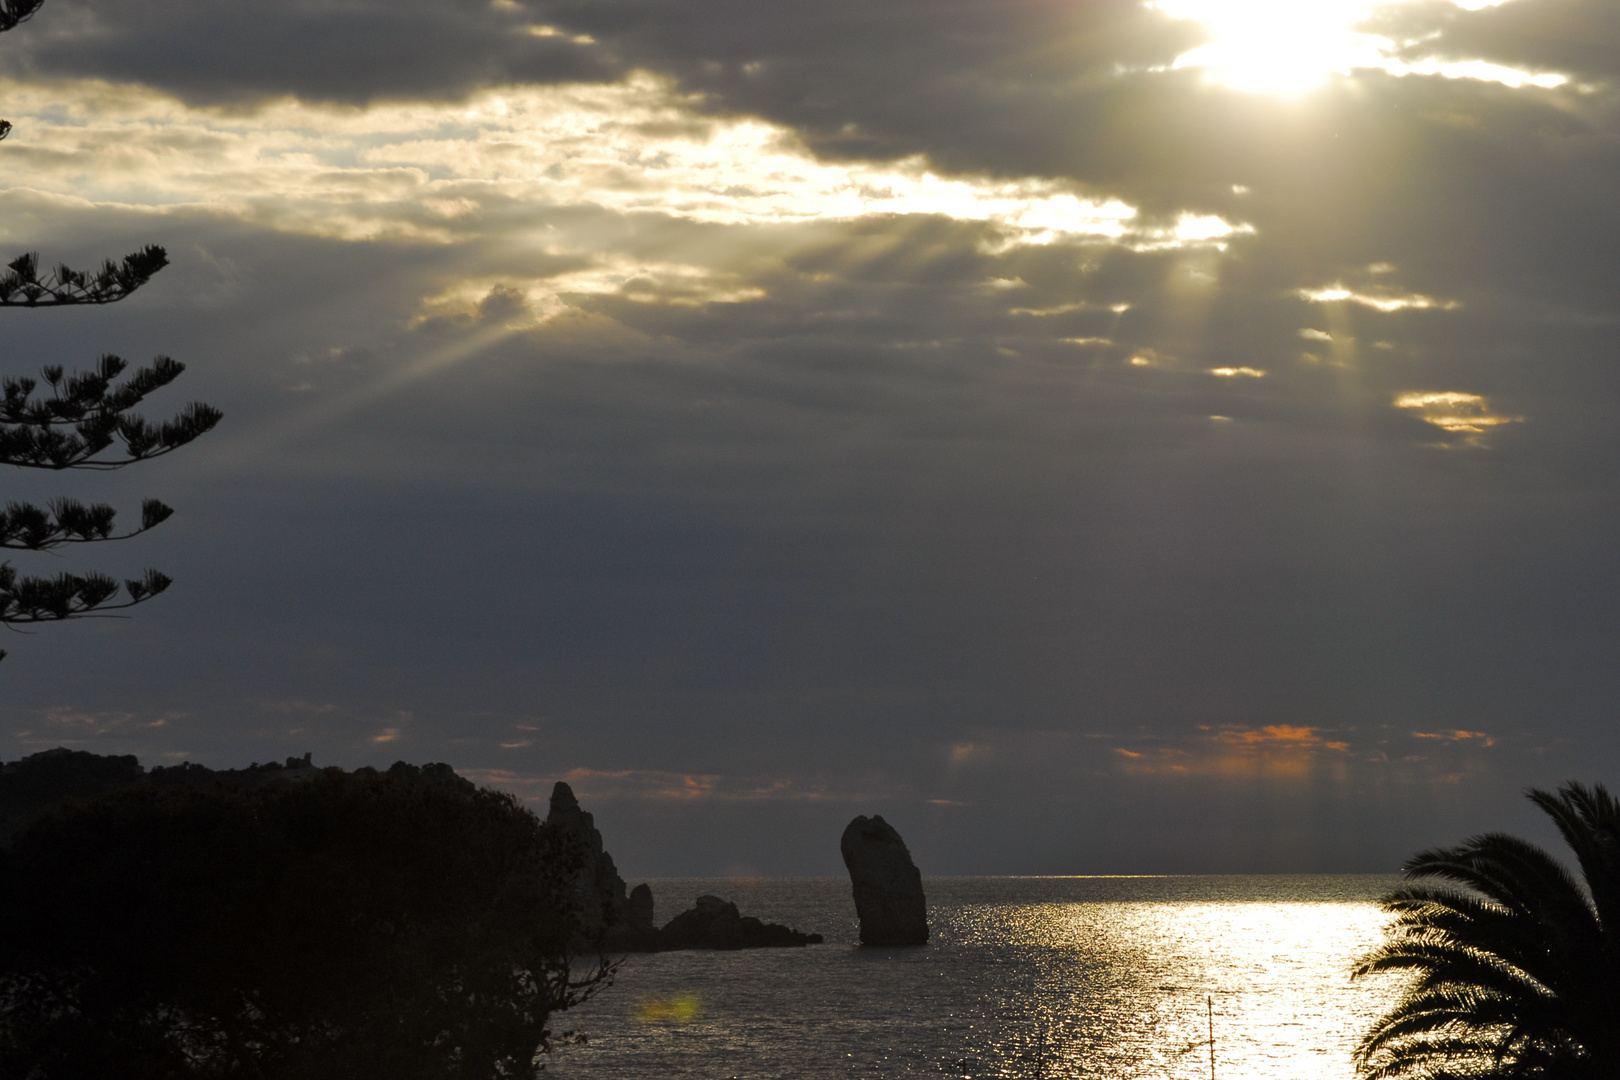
[548,876,1400,1080]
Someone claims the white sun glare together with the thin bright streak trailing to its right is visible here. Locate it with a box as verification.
[1149,0,1568,96]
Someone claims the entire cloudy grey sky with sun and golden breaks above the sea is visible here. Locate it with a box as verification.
[0,0,1620,879]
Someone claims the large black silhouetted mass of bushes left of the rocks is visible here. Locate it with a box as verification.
[0,764,612,1080]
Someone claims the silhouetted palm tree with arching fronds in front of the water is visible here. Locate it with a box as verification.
[1356,782,1620,1080]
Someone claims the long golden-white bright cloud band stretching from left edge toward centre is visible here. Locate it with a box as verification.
[0,74,1252,249]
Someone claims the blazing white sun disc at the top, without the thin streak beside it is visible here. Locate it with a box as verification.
[1150,0,1388,96]
